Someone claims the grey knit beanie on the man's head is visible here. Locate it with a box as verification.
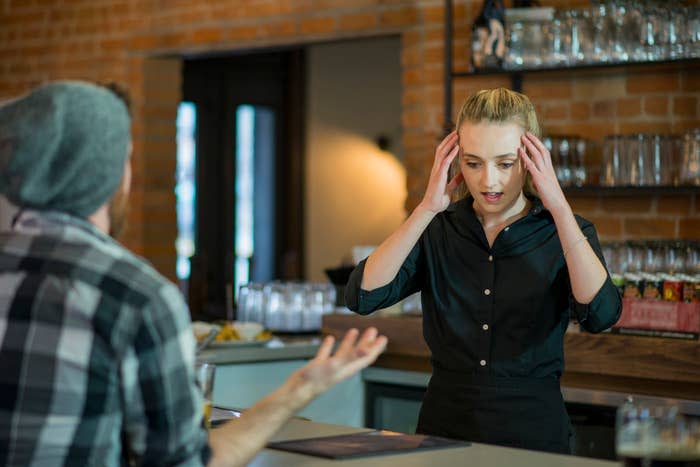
[0,81,131,218]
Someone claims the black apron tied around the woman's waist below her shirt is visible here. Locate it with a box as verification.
[416,368,572,454]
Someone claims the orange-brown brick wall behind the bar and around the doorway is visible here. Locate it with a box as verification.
[0,0,700,277]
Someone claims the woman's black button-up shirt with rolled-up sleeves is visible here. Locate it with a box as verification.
[346,197,621,378]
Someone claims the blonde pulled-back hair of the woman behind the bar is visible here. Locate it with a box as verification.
[450,88,541,201]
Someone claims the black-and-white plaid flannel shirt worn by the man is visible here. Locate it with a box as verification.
[0,211,210,466]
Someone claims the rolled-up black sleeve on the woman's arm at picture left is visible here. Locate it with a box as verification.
[345,242,423,315]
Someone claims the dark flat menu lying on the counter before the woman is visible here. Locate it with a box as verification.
[267,430,470,459]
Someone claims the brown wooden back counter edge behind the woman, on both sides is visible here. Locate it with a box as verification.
[322,314,700,400]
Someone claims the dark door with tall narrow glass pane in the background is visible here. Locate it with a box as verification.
[183,50,303,318]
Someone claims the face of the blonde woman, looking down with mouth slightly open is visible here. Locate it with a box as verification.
[459,122,527,216]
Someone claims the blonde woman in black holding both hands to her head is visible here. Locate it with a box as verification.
[346,89,621,453]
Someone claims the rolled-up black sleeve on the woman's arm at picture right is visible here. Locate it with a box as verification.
[569,222,622,333]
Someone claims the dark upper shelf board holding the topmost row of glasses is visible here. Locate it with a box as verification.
[451,57,700,78]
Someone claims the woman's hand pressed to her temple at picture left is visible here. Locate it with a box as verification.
[419,131,463,214]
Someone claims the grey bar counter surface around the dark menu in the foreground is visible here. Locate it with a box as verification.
[248,419,621,467]
